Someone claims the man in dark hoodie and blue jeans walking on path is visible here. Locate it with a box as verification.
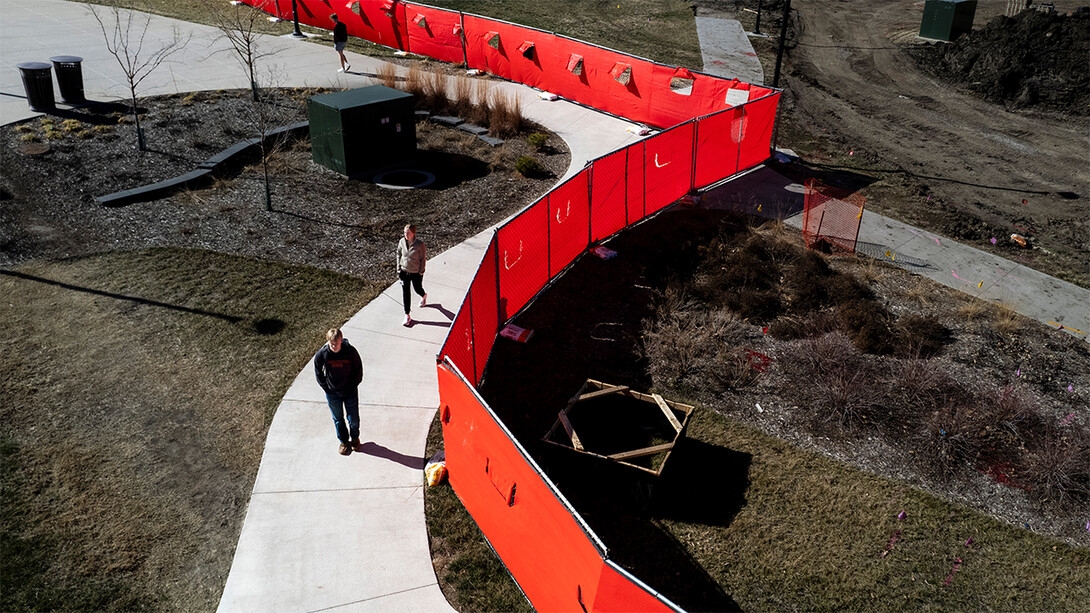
[314,328,363,456]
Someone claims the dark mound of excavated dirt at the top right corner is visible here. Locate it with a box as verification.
[916,11,1090,116]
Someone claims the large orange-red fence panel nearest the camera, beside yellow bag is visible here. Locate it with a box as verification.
[438,364,603,611]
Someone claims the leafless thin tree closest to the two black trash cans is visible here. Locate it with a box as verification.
[86,2,190,152]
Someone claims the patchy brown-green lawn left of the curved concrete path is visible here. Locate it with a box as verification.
[0,249,380,612]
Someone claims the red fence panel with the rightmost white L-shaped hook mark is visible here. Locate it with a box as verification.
[643,121,695,215]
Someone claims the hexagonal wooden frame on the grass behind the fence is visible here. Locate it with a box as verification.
[542,378,693,477]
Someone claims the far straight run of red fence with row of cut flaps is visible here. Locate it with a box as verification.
[244,0,775,127]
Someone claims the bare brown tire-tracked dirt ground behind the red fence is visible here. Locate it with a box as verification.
[698,0,1090,287]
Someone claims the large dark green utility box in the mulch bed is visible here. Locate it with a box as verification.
[306,85,416,177]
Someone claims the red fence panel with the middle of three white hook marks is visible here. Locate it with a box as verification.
[547,168,591,278]
